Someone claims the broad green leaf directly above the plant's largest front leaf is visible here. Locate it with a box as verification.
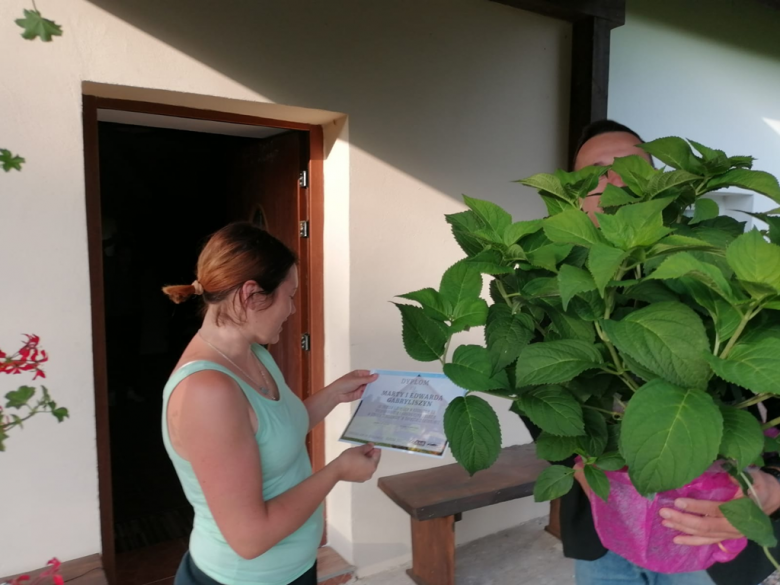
[602,302,710,388]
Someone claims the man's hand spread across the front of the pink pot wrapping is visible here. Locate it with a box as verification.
[659,469,780,546]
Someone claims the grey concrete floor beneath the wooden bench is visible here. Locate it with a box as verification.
[356,518,574,585]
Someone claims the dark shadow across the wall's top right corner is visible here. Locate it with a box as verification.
[626,0,780,60]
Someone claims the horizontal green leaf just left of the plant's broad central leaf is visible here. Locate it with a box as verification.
[517,339,604,388]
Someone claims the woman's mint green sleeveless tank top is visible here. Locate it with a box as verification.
[162,345,323,585]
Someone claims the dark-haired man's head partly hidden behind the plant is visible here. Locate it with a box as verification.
[573,120,653,217]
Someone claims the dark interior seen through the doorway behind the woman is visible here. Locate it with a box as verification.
[99,122,307,585]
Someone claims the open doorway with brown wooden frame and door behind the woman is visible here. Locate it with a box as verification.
[85,97,324,585]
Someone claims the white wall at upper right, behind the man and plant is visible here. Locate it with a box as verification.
[609,0,780,221]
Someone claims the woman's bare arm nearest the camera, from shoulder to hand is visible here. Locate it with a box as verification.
[177,372,379,559]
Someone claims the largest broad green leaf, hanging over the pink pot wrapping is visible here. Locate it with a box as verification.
[620,379,723,495]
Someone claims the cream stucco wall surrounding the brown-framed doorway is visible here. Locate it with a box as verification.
[0,0,568,575]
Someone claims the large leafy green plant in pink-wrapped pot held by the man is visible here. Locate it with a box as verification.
[397,137,780,572]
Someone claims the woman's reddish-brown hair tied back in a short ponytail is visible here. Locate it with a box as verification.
[162,222,297,322]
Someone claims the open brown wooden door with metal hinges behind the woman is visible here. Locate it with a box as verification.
[231,131,310,399]
